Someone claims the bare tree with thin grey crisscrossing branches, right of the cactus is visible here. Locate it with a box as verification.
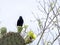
[32,0,60,45]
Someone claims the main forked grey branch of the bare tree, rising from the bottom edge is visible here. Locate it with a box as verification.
[37,2,58,45]
